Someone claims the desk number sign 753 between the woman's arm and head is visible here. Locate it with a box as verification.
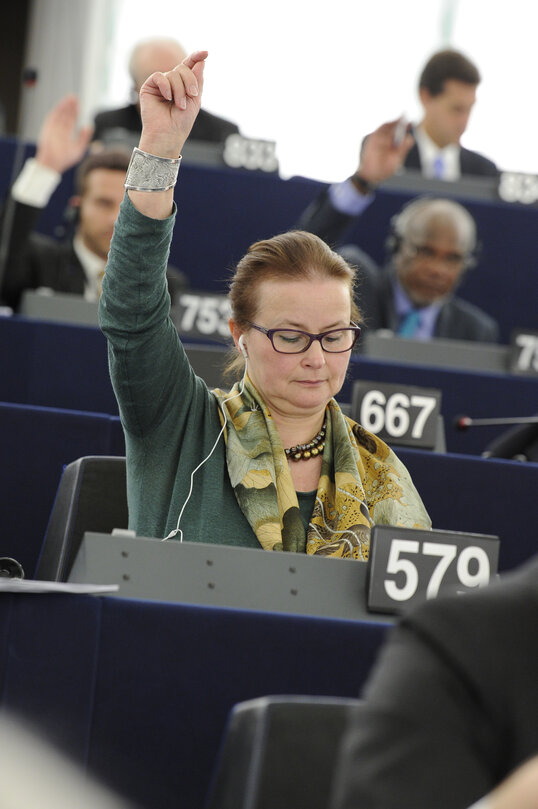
[170,292,231,343]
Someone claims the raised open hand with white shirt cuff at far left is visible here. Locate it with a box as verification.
[36,94,92,174]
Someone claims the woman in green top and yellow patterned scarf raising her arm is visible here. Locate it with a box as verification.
[100,51,430,561]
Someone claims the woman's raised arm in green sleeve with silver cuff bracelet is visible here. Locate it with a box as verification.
[99,51,209,438]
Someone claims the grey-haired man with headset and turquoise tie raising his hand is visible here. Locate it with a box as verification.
[298,121,499,342]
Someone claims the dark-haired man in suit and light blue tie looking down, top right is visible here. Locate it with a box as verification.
[404,49,499,180]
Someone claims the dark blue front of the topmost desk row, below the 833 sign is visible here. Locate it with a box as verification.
[0,139,538,342]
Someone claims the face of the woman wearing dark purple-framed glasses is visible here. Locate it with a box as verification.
[232,278,351,416]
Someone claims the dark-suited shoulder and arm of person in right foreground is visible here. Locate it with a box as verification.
[331,557,538,809]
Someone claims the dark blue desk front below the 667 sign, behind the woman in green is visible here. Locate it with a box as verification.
[0,403,538,600]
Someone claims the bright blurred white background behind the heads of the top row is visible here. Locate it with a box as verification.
[4,0,538,181]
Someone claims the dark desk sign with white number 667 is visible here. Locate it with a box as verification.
[351,379,441,449]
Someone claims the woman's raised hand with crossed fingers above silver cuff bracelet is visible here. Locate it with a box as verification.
[136,51,207,157]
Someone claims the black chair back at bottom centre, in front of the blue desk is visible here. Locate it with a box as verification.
[206,696,360,809]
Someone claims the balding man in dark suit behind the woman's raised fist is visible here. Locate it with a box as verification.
[93,38,239,146]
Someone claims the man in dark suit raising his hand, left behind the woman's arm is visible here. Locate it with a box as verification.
[0,95,189,311]
